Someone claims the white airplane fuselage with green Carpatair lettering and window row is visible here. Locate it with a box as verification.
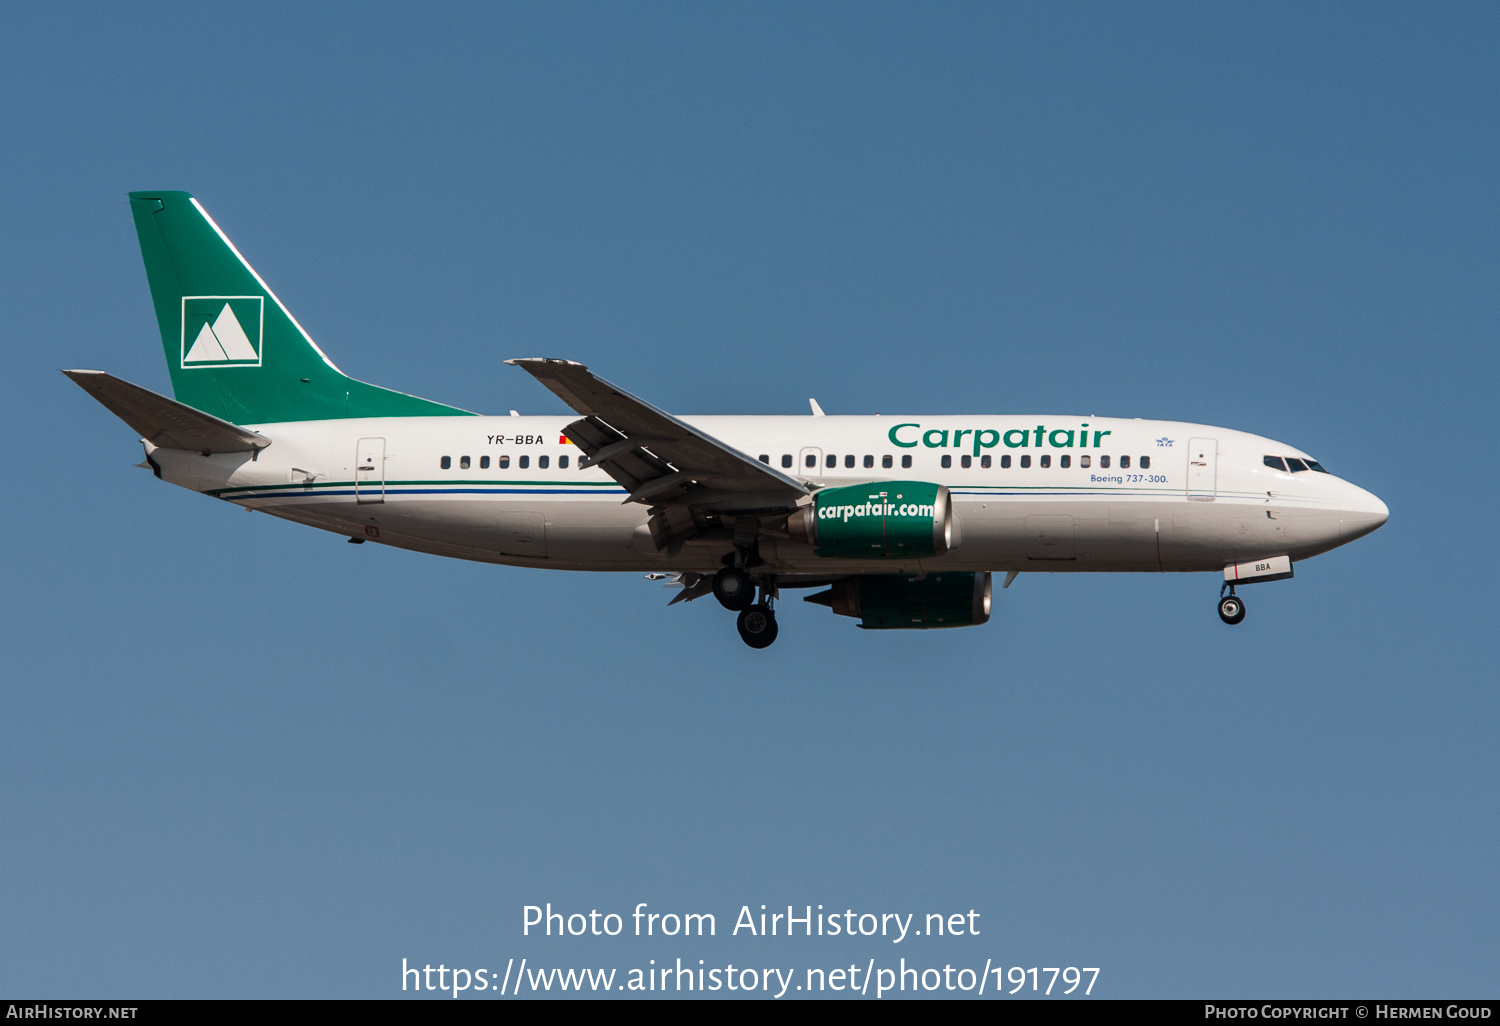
[150,416,1388,579]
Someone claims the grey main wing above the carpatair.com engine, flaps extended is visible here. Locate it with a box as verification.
[506,359,809,515]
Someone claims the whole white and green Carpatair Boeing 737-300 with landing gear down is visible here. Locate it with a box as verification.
[63,192,1388,648]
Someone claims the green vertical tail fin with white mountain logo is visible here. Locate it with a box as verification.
[131,192,468,425]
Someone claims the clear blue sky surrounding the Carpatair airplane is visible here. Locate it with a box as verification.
[0,3,1500,998]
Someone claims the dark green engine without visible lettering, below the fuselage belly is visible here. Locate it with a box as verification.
[807,573,992,630]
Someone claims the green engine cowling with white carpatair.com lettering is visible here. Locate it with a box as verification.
[786,482,953,560]
